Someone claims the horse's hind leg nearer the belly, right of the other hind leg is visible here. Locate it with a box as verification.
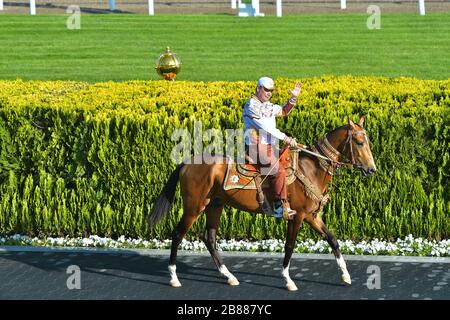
[203,199,239,286]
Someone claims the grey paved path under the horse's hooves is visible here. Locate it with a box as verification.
[0,246,450,300]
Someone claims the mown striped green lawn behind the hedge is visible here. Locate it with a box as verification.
[0,13,450,82]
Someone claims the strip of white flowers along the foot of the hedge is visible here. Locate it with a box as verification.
[0,234,450,257]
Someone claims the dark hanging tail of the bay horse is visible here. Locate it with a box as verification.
[148,163,184,229]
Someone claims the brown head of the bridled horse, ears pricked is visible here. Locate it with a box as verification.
[325,117,377,176]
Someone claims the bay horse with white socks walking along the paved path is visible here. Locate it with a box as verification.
[148,117,376,291]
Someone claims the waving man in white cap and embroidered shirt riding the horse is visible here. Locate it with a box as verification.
[243,77,302,220]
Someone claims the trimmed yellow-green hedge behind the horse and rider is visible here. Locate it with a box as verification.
[0,76,450,240]
